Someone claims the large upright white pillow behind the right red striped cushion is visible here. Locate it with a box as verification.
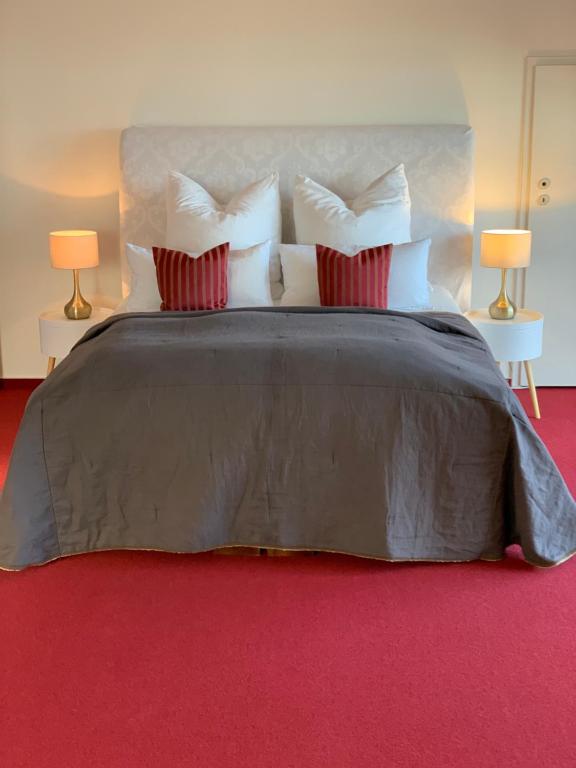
[294,164,412,248]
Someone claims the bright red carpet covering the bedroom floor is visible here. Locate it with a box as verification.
[0,380,576,768]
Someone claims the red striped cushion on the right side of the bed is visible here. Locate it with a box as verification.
[316,245,392,309]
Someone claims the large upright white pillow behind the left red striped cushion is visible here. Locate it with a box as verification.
[166,171,282,294]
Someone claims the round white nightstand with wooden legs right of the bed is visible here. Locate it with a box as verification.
[465,309,544,419]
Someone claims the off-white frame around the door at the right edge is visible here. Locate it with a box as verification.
[510,51,576,387]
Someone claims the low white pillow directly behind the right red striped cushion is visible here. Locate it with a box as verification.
[280,239,431,312]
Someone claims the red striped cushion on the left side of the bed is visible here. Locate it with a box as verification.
[152,243,230,312]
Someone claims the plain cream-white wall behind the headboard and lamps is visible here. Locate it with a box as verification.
[0,0,576,377]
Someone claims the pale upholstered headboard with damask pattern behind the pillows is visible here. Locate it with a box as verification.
[120,125,474,309]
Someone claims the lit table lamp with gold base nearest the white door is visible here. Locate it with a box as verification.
[480,229,532,320]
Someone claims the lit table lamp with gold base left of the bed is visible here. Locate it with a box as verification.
[50,229,98,320]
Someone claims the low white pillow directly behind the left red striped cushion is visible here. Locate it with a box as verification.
[115,240,272,313]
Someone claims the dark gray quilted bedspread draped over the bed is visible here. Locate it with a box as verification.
[0,308,576,569]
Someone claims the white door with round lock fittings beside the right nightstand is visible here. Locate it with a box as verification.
[524,64,576,386]
